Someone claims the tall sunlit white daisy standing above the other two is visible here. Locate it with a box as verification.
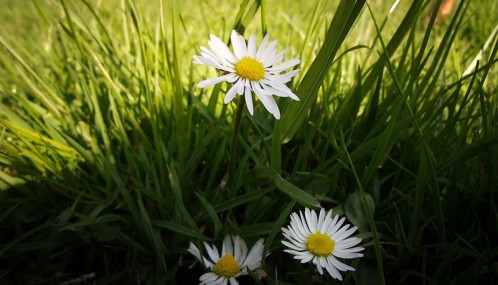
[193,30,300,119]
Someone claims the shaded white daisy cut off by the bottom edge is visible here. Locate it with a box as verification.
[188,235,264,285]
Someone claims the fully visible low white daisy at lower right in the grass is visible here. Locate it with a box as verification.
[282,208,364,281]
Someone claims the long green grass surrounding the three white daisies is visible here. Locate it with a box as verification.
[0,0,498,284]
